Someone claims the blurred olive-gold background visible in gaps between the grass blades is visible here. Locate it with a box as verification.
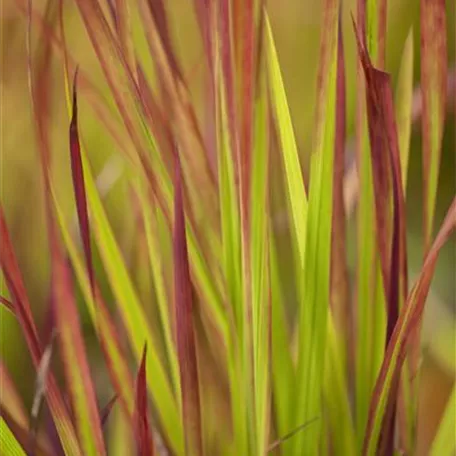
[0,0,456,454]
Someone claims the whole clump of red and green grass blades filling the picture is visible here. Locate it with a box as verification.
[0,0,456,456]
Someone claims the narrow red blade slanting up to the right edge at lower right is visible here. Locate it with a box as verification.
[363,198,456,455]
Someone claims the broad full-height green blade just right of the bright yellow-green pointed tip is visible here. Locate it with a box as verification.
[293,0,340,454]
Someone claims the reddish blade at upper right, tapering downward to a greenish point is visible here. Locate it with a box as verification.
[420,0,448,253]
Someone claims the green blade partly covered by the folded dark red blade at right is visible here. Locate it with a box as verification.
[355,0,386,444]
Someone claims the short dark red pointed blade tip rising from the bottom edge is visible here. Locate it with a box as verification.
[134,345,155,456]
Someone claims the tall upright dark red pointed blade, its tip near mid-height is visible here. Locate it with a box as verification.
[173,150,203,455]
